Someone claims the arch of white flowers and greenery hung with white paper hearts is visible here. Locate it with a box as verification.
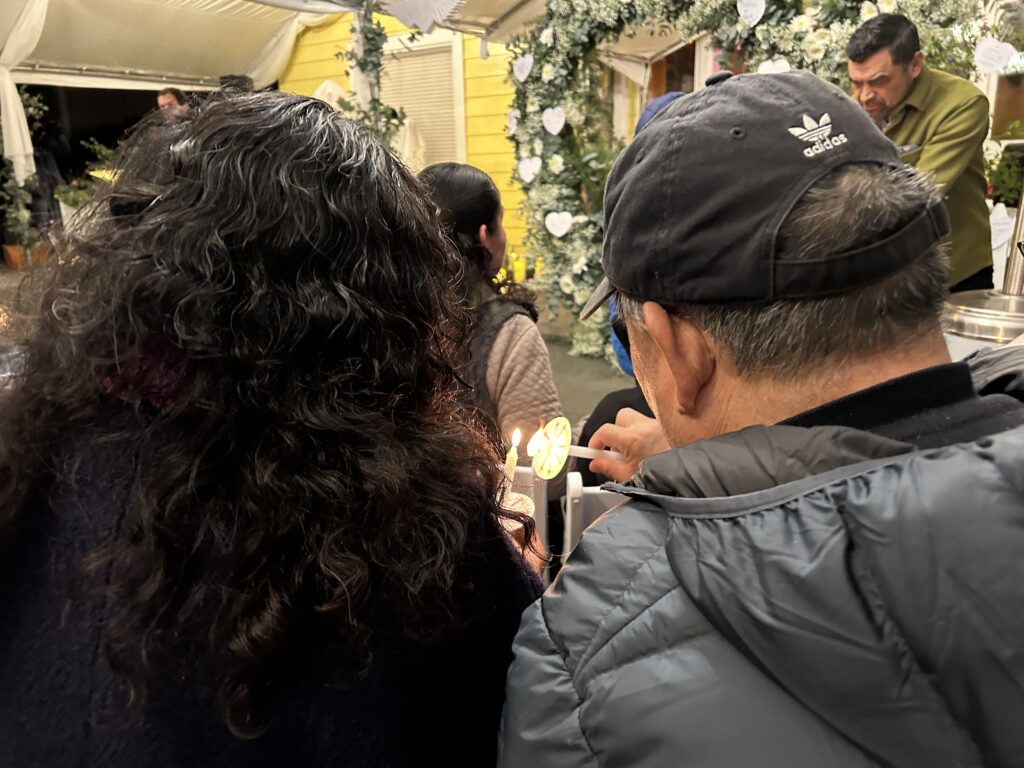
[508,0,984,356]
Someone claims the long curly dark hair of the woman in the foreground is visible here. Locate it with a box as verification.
[0,93,531,736]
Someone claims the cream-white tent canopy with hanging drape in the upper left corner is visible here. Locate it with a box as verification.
[0,0,327,182]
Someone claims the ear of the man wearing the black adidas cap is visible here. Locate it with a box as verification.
[643,301,716,414]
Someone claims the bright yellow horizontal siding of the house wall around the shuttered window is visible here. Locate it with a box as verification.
[281,14,526,252]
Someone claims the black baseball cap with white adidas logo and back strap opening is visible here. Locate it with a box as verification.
[581,72,949,318]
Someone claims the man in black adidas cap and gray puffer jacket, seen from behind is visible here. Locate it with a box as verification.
[499,72,1024,768]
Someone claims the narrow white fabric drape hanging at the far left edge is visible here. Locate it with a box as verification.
[0,0,47,184]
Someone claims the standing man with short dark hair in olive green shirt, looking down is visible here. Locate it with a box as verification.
[846,13,992,292]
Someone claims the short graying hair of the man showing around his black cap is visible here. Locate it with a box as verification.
[618,165,947,380]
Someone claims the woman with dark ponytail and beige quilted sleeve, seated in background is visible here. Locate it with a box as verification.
[420,163,561,448]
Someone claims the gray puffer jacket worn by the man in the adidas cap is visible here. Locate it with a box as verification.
[500,350,1024,768]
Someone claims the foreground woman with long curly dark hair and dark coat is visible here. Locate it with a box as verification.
[0,93,540,768]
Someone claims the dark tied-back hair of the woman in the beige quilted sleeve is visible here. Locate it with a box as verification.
[420,163,537,308]
